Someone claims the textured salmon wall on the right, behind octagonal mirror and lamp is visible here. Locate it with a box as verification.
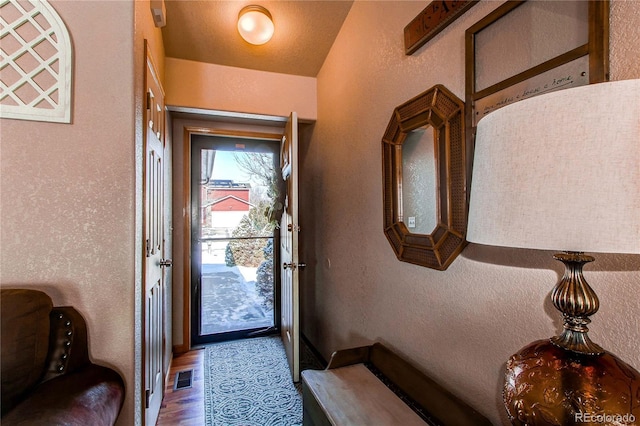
[301,1,640,424]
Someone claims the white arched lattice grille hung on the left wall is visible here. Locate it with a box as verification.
[0,0,72,123]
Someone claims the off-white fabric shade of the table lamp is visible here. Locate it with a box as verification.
[467,80,640,253]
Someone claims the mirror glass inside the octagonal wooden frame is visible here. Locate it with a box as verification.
[398,126,438,234]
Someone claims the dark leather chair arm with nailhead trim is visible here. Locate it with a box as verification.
[43,306,91,381]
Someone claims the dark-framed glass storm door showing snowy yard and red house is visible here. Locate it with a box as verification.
[191,135,281,344]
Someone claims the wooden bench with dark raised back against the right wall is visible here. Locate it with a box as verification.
[302,343,491,426]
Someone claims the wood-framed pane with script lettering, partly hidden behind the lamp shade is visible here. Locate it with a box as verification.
[465,0,609,141]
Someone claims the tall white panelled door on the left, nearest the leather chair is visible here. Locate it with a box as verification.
[143,45,171,425]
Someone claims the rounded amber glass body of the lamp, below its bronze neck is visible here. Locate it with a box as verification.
[503,339,640,426]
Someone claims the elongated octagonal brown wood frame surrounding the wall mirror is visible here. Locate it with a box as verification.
[382,85,468,271]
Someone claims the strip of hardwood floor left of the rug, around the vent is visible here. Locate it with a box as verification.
[157,349,204,426]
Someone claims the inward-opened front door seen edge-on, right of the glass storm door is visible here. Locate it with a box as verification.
[280,112,304,382]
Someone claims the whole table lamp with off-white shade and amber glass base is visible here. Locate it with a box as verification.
[467,80,640,425]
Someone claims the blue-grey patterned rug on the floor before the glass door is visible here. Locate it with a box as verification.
[204,336,310,426]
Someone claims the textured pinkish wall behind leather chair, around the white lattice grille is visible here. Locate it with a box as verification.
[0,1,136,425]
